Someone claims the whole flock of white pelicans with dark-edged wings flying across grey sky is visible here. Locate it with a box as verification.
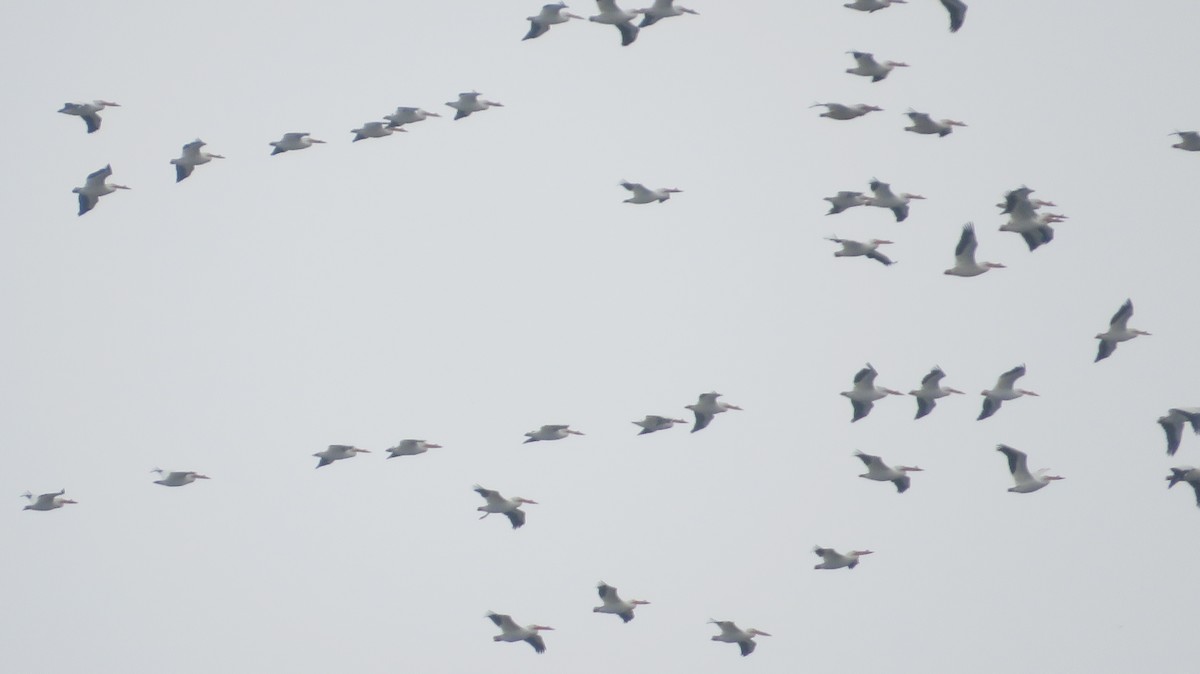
[23,0,1200,656]
